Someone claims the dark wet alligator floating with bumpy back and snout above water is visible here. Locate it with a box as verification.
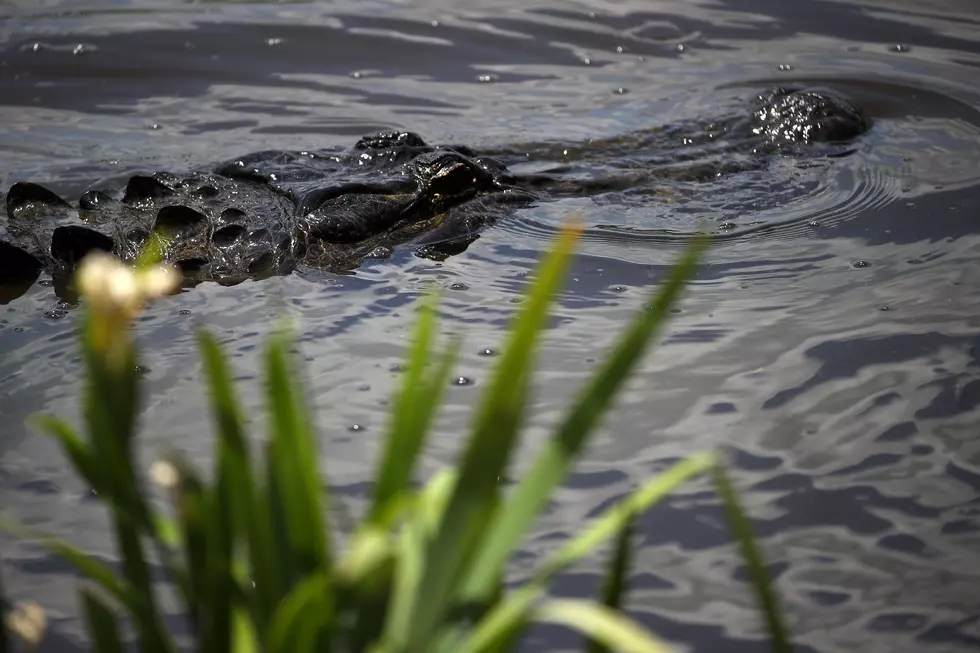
[0,87,871,300]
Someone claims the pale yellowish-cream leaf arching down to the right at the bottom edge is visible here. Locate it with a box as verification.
[533,599,673,653]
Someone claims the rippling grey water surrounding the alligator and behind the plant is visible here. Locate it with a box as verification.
[0,0,980,652]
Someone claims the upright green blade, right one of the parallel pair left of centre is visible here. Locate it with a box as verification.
[266,333,331,585]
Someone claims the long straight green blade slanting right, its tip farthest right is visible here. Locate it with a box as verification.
[463,234,707,600]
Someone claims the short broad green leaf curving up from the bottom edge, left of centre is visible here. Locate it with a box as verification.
[266,572,332,653]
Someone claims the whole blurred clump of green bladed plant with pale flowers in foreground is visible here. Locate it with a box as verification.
[0,228,790,653]
